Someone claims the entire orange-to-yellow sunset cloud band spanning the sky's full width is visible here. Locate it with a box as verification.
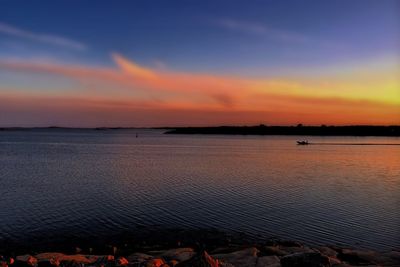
[0,54,400,126]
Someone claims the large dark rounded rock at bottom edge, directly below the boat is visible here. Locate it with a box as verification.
[281,252,331,267]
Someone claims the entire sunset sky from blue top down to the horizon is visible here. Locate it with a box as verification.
[0,0,400,127]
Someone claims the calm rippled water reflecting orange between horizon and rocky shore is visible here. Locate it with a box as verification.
[0,130,400,249]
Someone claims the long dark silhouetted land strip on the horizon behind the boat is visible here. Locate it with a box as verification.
[165,124,400,136]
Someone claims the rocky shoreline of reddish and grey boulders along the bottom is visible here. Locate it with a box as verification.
[0,240,400,267]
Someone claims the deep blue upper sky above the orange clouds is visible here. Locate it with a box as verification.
[0,0,400,75]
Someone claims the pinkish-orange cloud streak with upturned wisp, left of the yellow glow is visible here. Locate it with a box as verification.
[0,54,304,108]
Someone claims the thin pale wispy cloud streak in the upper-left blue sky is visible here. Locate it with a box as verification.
[0,22,86,50]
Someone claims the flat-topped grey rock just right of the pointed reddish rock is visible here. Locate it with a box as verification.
[212,247,259,267]
